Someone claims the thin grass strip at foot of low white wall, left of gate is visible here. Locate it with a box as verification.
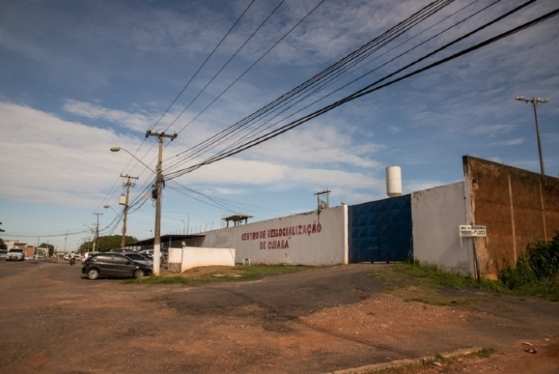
[126,265,311,286]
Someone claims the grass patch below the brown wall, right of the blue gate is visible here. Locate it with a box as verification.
[372,263,559,306]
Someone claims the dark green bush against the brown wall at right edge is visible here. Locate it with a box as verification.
[499,233,559,301]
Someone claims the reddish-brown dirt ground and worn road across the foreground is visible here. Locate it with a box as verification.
[0,262,559,373]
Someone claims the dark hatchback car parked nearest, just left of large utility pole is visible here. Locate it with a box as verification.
[82,252,152,280]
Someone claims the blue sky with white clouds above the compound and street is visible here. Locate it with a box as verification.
[0,0,559,249]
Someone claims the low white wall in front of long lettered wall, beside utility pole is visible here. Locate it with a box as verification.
[169,247,235,272]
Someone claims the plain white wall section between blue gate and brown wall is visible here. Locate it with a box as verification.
[411,182,474,275]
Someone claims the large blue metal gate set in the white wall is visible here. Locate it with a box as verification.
[348,195,412,262]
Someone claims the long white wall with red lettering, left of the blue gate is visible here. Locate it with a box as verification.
[195,205,348,265]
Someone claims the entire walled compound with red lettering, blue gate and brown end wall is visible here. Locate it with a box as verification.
[155,156,559,279]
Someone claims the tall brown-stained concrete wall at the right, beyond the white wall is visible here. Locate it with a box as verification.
[463,156,559,278]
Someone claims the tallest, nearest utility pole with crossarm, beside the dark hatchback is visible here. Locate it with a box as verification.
[146,130,177,275]
